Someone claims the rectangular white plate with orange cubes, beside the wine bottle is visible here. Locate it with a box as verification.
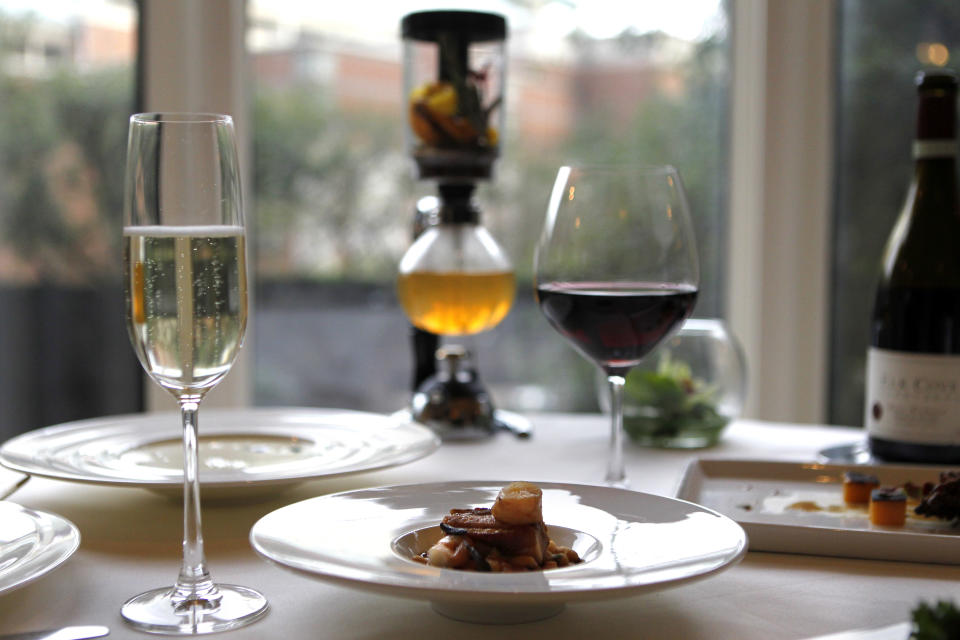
[677,459,960,564]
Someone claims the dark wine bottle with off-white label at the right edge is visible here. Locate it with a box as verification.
[864,70,960,464]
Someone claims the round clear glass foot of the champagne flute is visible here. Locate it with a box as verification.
[120,584,268,635]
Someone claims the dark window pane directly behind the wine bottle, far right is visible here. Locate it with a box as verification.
[829,0,960,425]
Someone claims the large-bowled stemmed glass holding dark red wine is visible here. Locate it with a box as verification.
[534,165,700,486]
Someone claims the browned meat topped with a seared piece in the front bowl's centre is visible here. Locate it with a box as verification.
[413,482,581,573]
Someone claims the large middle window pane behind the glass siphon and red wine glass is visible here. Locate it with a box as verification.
[247,0,729,411]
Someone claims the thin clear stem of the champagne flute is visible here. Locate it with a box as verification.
[173,396,220,607]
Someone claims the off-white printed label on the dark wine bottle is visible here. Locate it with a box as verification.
[864,347,960,445]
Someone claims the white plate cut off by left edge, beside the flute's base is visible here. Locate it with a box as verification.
[0,501,80,594]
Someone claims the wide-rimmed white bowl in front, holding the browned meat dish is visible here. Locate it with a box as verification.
[250,482,747,623]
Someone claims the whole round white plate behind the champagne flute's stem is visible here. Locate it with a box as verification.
[0,408,440,498]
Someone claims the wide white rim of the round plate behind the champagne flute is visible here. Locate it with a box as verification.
[0,407,441,490]
